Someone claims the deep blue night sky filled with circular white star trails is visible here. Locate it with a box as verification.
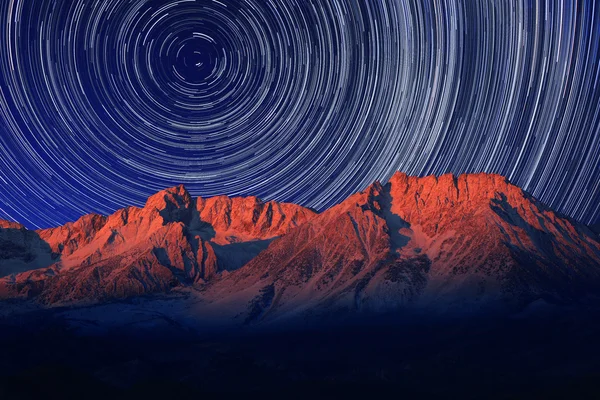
[0,0,600,227]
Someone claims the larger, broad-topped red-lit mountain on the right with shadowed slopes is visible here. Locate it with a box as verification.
[197,173,600,323]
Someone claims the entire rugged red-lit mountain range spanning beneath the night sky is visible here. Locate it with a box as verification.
[1,173,600,323]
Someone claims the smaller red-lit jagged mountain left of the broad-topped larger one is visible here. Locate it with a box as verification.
[0,186,314,303]
